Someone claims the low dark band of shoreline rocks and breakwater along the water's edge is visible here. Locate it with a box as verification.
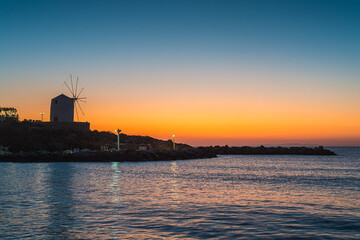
[0,146,336,162]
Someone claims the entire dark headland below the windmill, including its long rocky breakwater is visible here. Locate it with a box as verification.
[0,121,336,162]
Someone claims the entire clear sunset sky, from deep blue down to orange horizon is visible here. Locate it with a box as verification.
[0,0,360,146]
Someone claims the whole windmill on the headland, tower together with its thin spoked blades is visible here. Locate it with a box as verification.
[50,75,86,122]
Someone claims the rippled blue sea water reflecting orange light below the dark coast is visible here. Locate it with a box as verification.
[0,148,360,239]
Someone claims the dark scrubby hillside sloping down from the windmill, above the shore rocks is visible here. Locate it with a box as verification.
[0,121,191,152]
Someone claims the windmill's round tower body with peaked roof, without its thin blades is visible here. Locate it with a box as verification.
[50,94,74,122]
